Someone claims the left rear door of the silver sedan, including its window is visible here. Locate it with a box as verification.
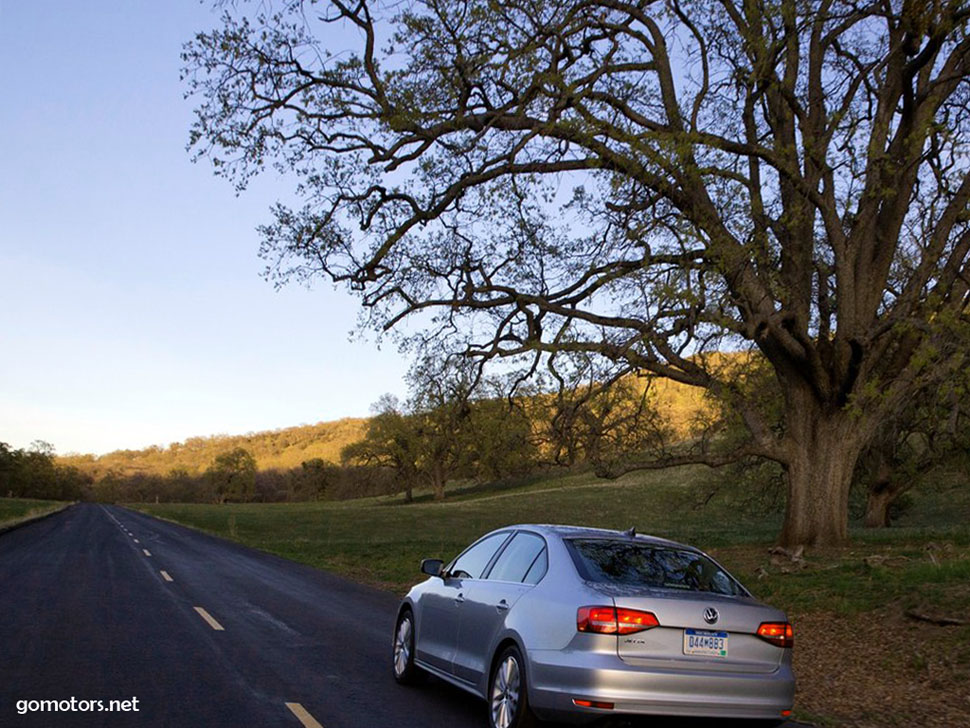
[454,531,546,684]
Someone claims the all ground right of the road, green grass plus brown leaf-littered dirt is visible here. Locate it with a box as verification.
[140,467,970,727]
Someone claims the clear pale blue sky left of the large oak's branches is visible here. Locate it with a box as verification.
[0,0,406,453]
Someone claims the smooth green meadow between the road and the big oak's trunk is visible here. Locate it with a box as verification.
[143,470,777,591]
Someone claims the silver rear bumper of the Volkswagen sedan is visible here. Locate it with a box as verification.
[529,650,795,723]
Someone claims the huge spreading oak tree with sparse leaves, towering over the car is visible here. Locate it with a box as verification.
[185,0,970,544]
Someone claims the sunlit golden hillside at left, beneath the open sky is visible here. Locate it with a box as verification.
[57,418,367,480]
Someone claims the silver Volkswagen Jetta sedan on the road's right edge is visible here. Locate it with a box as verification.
[393,525,795,728]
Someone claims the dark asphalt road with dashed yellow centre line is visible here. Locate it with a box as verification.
[0,504,804,728]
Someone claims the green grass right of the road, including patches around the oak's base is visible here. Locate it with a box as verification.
[132,467,970,600]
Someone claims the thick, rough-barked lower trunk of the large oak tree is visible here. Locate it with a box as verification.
[779,392,865,548]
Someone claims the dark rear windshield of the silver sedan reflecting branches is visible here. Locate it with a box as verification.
[566,539,745,595]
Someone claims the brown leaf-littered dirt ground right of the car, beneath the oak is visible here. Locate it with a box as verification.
[704,544,970,728]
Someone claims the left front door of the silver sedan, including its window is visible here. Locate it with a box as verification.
[415,531,511,673]
